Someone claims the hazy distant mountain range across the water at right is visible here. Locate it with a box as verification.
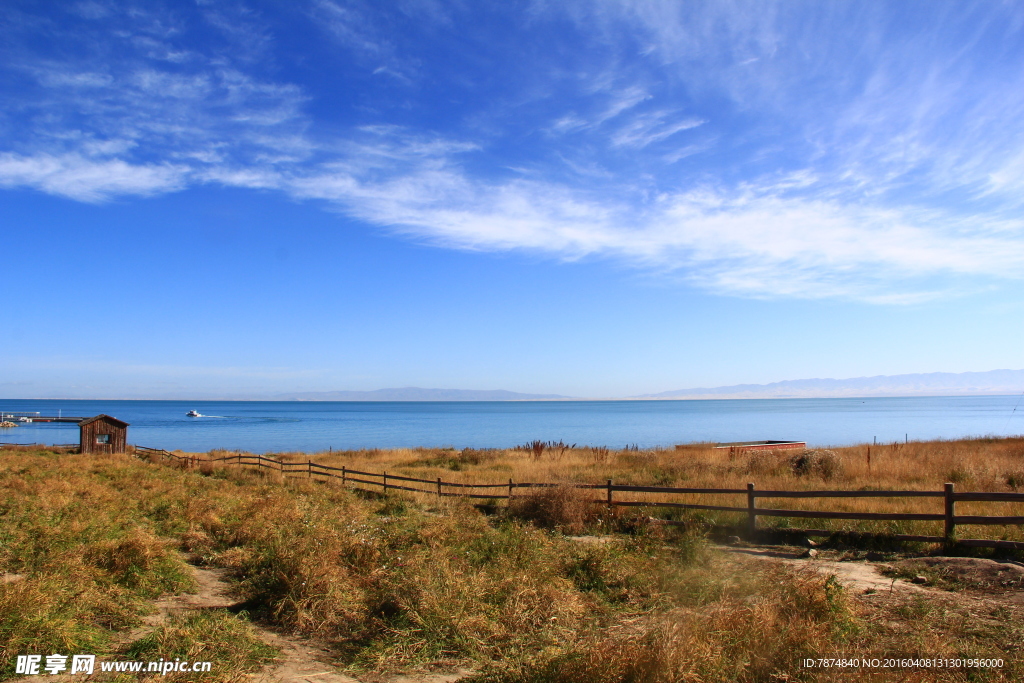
[633,370,1024,398]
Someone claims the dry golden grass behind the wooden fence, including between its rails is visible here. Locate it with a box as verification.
[188,438,1024,541]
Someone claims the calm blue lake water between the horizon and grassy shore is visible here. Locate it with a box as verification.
[0,396,1024,453]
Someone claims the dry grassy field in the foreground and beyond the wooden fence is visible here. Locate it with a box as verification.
[0,441,1024,683]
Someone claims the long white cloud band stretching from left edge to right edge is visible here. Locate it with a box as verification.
[0,112,1024,303]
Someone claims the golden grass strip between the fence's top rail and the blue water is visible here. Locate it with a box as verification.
[228,438,1024,490]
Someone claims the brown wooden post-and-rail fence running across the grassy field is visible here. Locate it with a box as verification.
[134,445,1024,550]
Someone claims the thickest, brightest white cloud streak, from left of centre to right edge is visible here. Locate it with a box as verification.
[278,143,1024,302]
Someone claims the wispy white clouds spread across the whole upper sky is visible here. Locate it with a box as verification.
[0,0,1024,303]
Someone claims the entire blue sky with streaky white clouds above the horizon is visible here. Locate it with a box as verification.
[0,0,1024,397]
